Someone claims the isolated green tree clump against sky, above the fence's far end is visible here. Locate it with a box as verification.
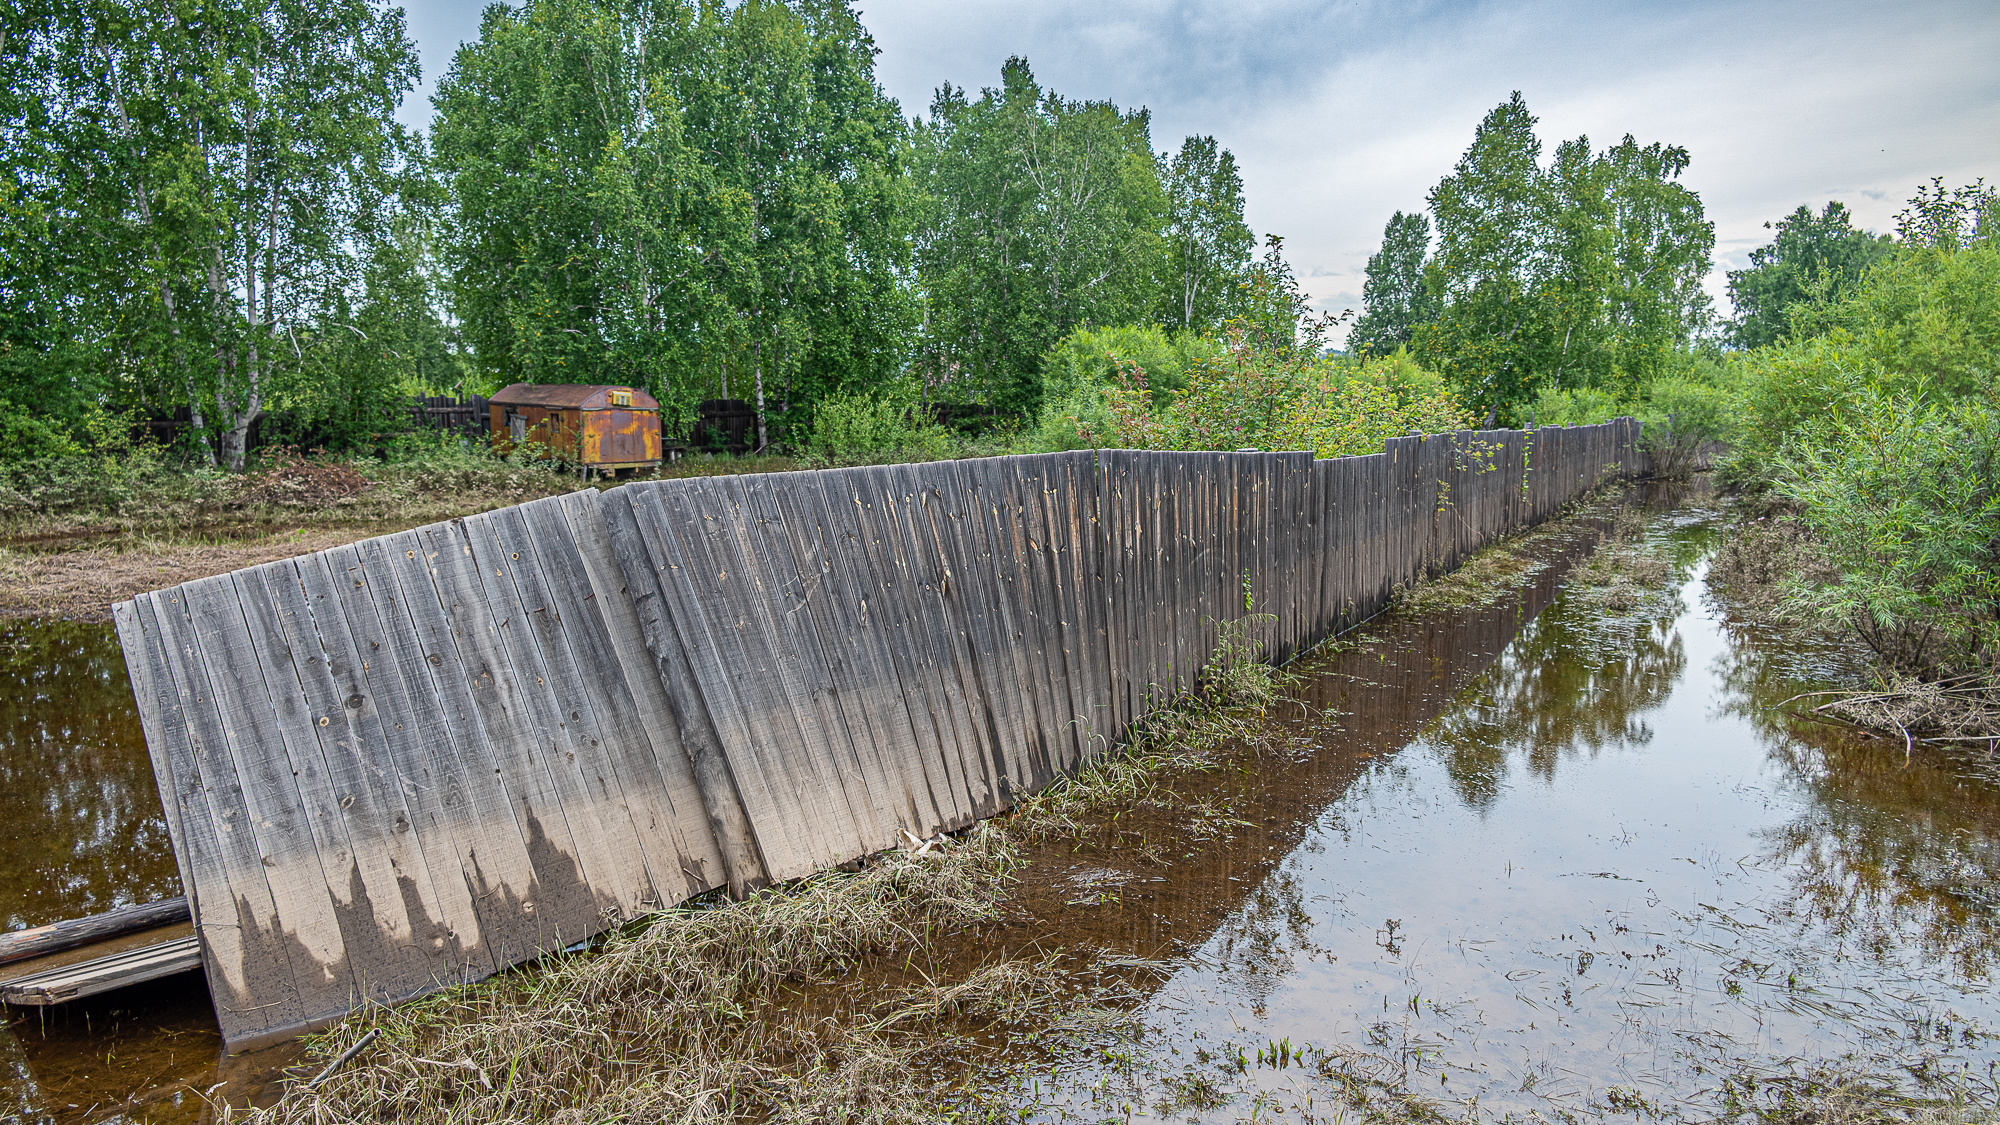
[1410,92,1714,418]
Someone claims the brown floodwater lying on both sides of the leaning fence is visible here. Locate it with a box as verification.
[0,492,2000,1121]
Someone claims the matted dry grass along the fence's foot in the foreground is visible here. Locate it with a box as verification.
[238,827,1032,1125]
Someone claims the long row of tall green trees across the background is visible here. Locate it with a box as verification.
[0,0,1936,468]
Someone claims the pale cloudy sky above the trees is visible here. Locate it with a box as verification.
[404,0,2000,340]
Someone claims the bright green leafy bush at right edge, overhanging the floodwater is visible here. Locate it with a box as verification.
[1776,390,2000,673]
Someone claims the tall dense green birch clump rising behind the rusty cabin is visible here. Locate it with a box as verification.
[436,0,914,434]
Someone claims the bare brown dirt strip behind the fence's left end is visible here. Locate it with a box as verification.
[0,526,406,621]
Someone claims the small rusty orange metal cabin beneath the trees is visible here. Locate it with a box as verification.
[488,382,660,472]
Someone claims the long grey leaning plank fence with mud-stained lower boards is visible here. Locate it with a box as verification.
[116,420,1638,1049]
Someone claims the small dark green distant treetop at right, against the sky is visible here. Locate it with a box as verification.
[1730,200,1896,348]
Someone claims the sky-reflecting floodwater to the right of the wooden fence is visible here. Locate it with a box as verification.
[1008,488,2000,1121]
